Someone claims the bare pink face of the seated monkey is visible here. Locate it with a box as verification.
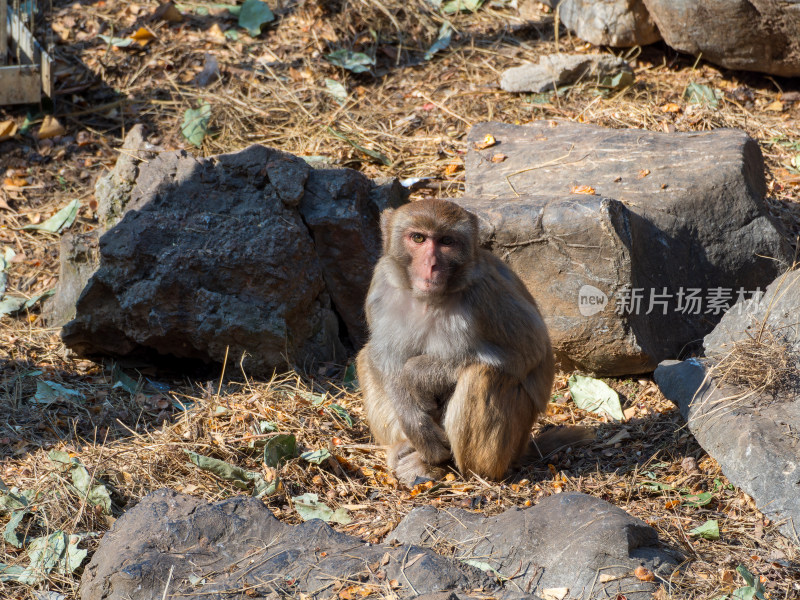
[403,231,459,295]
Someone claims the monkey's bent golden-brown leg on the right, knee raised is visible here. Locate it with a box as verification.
[444,365,538,479]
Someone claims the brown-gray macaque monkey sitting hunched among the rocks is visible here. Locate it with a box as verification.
[356,200,554,485]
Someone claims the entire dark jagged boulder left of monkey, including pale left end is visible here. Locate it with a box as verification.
[47,131,406,374]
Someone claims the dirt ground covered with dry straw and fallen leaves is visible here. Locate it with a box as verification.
[0,0,800,600]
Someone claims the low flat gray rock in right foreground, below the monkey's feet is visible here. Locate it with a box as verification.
[389,493,677,600]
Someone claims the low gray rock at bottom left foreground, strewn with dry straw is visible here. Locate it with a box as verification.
[80,490,497,600]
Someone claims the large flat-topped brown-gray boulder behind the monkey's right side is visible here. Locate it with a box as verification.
[458,122,792,375]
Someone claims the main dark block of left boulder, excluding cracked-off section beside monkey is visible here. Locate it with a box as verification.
[62,146,343,373]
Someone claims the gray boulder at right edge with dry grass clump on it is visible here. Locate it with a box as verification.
[655,271,800,546]
